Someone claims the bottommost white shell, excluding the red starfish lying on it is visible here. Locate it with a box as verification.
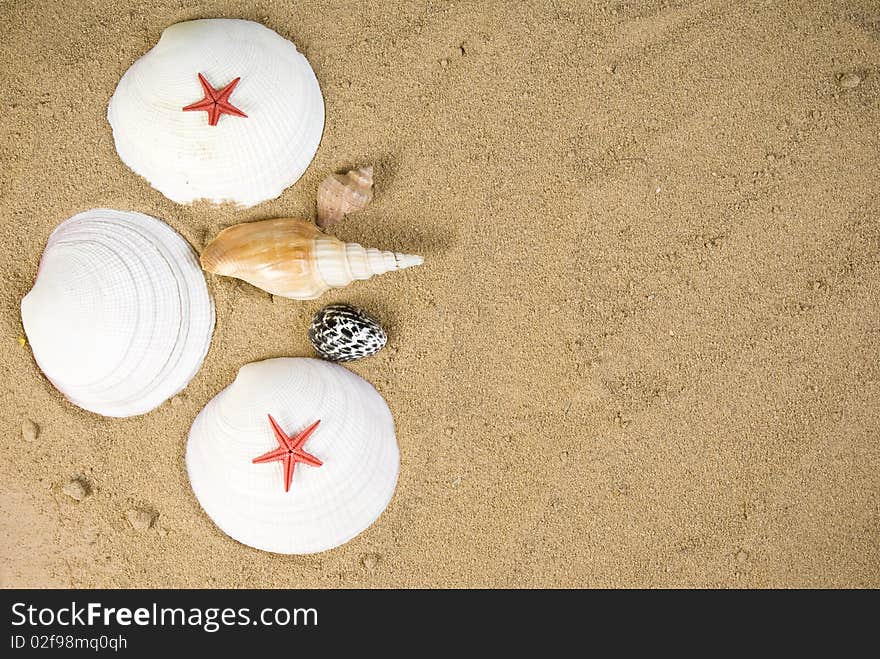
[186,358,400,554]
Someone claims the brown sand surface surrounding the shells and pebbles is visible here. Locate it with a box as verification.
[0,0,880,587]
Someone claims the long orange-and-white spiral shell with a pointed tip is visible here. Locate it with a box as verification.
[200,217,423,300]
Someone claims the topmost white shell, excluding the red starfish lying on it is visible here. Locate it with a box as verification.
[107,18,324,206]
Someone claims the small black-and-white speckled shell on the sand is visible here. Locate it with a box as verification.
[309,304,388,362]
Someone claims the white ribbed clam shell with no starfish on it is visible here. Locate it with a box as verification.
[21,208,214,417]
